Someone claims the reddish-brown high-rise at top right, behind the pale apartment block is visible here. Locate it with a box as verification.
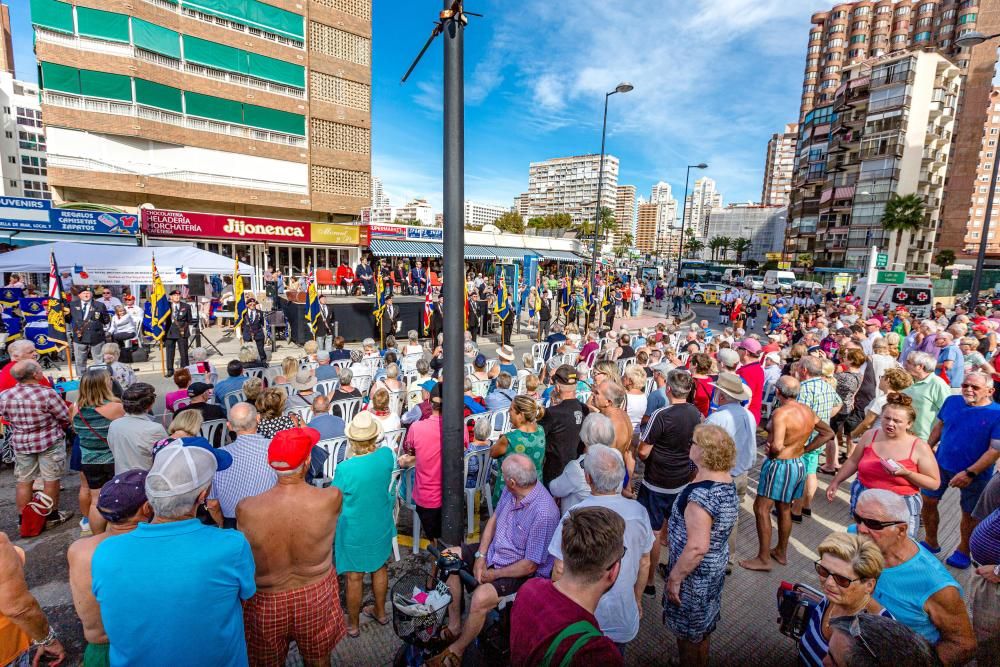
[799,0,1000,264]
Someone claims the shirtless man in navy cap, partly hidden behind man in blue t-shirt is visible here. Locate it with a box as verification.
[66,470,153,665]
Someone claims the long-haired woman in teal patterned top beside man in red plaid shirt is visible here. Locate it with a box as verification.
[73,369,125,535]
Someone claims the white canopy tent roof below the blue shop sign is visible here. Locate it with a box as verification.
[0,241,254,276]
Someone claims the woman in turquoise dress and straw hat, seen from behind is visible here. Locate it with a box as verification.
[333,411,396,637]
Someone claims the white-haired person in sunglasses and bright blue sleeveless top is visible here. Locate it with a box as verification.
[854,489,976,665]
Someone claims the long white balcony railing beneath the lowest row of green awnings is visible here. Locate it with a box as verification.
[41,90,306,148]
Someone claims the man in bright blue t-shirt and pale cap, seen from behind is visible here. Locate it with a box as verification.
[91,444,257,667]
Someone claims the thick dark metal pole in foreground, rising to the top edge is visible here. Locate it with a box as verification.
[435,0,465,545]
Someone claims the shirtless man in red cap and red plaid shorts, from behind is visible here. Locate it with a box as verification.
[236,428,347,666]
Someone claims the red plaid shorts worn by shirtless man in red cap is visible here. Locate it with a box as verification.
[243,567,347,667]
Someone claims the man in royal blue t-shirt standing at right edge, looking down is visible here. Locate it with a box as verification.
[921,372,1000,570]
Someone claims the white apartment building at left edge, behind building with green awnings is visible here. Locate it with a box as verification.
[0,71,52,199]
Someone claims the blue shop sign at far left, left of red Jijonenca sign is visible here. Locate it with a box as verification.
[0,197,139,236]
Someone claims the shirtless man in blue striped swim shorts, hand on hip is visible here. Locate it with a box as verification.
[740,375,833,572]
